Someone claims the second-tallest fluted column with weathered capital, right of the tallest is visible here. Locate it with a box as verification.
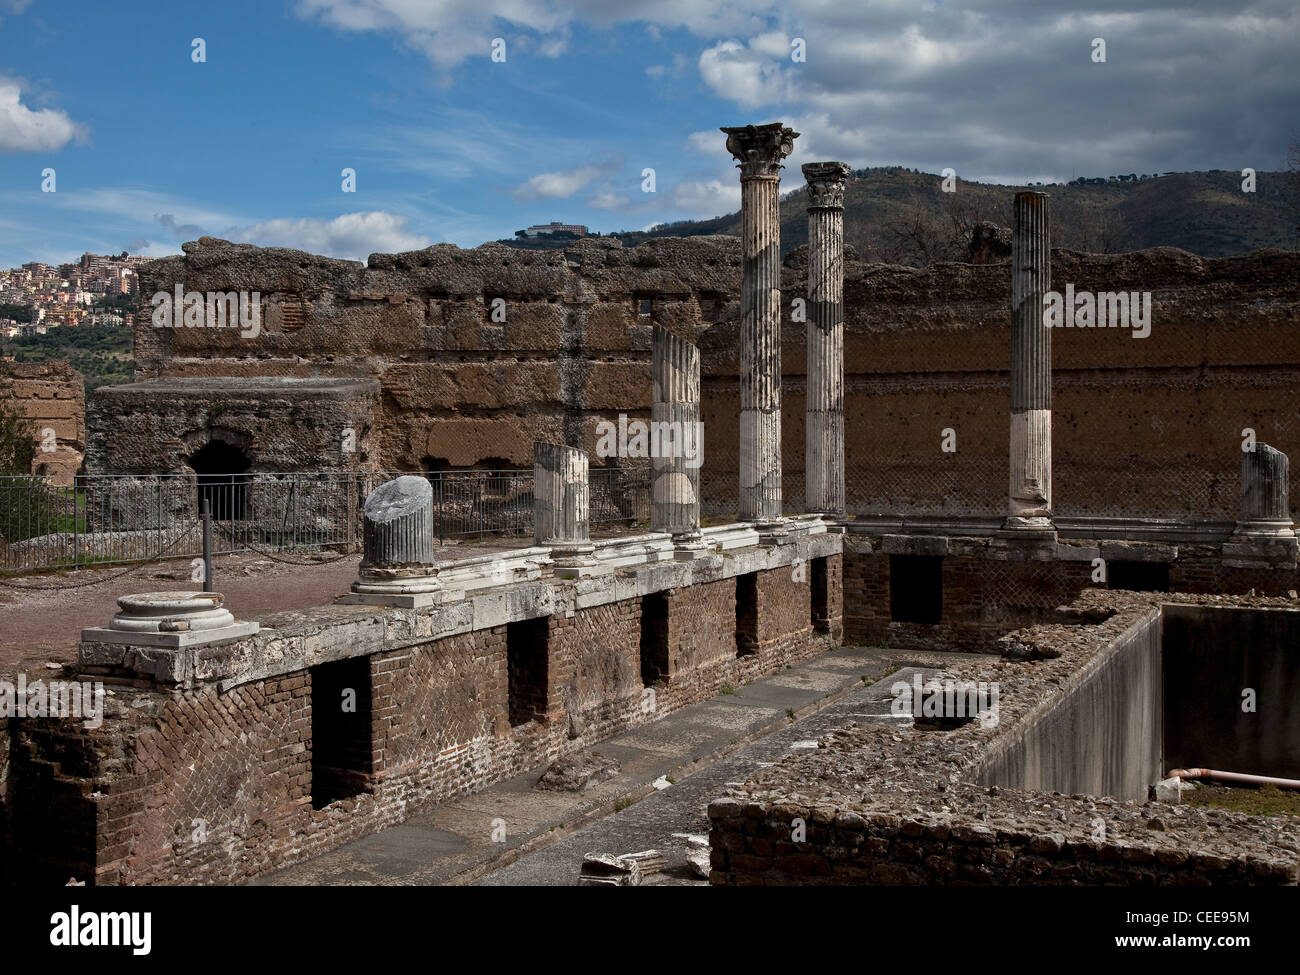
[803,163,849,517]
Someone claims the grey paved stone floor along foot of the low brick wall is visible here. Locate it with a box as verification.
[254,647,959,885]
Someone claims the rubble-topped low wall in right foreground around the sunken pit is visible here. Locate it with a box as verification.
[709,592,1300,887]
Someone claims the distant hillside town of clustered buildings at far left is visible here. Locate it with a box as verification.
[0,251,152,338]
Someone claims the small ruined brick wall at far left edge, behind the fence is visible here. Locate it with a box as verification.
[0,360,86,485]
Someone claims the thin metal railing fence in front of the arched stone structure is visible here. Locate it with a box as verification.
[0,468,650,573]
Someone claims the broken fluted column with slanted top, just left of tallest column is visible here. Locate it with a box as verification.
[650,325,706,559]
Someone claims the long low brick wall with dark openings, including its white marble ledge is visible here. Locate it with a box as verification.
[0,534,841,884]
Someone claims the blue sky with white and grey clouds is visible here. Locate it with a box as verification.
[0,0,1300,267]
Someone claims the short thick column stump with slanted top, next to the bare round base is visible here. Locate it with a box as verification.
[346,475,441,607]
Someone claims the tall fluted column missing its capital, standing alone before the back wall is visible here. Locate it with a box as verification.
[1004,190,1054,533]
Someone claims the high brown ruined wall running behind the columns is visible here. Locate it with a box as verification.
[106,237,1300,517]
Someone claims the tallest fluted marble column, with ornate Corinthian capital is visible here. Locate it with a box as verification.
[723,122,798,537]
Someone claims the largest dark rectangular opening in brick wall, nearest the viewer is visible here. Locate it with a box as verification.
[308,657,374,809]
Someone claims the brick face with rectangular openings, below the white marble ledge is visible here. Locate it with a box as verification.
[5,555,839,884]
